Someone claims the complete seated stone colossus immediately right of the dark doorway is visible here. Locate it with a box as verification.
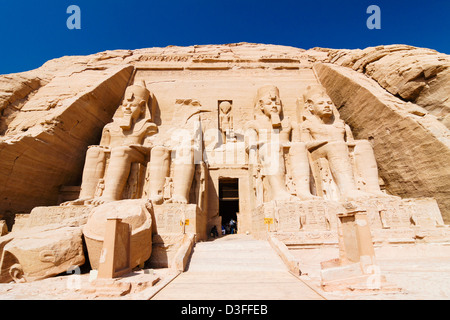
[245,85,315,201]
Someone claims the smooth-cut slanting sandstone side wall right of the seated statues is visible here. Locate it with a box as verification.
[315,64,450,223]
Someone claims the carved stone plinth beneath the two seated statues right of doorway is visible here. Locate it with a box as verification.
[253,197,449,245]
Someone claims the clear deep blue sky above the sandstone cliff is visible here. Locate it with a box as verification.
[0,0,450,74]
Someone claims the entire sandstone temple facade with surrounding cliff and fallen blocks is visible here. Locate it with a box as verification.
[0,43,450,288]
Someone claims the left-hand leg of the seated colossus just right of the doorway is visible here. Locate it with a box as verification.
[259,143,298,201]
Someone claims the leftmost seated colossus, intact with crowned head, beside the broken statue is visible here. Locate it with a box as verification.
[63,85,158,205]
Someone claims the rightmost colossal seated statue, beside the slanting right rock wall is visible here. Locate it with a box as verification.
[294,86,388,200]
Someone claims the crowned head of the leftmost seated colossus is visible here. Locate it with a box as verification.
[120,84,150,130]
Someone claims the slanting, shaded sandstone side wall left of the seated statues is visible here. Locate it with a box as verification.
[0,65,133,224]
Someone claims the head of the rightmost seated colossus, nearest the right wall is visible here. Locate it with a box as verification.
[303,86,335,119]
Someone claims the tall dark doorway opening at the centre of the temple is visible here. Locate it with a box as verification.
[219,178,239,234]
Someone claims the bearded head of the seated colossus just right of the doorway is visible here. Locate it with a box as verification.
[255,85,282,128]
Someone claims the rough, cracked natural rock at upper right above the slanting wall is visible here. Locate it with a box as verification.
[329,45,450,128]
